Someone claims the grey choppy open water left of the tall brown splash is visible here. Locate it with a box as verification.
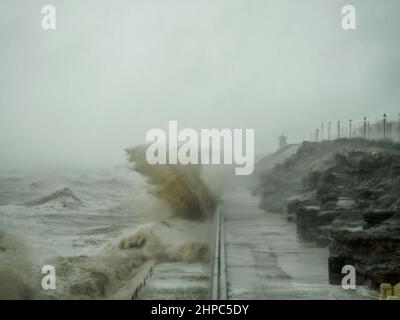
[0,168,142,266]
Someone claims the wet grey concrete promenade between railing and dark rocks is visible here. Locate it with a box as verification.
[222,192,376,299]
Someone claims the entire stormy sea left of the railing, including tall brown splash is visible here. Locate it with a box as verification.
[0,148,216,299]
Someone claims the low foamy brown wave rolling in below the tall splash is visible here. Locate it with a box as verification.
[39,224,209,299]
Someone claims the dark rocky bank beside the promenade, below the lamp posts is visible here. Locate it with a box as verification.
[258,141,400,286]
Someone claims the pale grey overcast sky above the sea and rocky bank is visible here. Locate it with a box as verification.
[0,0,400,169]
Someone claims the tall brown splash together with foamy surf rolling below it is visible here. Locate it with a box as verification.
[34,147,216,299]
